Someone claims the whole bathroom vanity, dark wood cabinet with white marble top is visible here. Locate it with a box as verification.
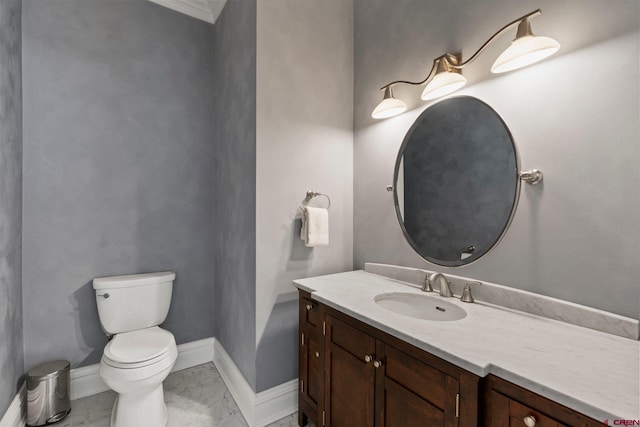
[295,271,640,427]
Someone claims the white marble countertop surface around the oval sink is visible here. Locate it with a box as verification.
[294,270,640,421]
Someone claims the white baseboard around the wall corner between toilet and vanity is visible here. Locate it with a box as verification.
[213,340,298,427]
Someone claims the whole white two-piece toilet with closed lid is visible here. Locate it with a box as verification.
[93,271,178,427]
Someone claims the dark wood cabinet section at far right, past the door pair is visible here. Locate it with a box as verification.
[483,375,603,427]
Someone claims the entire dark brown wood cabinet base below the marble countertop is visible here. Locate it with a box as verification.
[298,291,602,427]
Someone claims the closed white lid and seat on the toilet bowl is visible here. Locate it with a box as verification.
[104,326,176,368]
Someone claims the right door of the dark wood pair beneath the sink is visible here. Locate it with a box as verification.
[376,344,459,427]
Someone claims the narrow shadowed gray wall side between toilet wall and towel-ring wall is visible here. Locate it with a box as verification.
[212,0,256,389]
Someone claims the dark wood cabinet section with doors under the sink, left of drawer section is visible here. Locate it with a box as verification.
[299,292,479,427]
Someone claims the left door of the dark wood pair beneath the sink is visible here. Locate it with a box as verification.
[328,316,375,427]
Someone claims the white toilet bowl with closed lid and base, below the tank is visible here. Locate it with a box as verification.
[100,326,178,427]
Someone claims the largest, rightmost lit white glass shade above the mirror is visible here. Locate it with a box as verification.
[491,35,560,73]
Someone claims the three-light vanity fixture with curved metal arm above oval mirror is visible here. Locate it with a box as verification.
[371,9,560,119]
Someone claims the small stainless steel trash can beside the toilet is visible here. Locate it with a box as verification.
[27,360,71,426]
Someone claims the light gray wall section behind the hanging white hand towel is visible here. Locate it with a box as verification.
[256,0,353,392]
